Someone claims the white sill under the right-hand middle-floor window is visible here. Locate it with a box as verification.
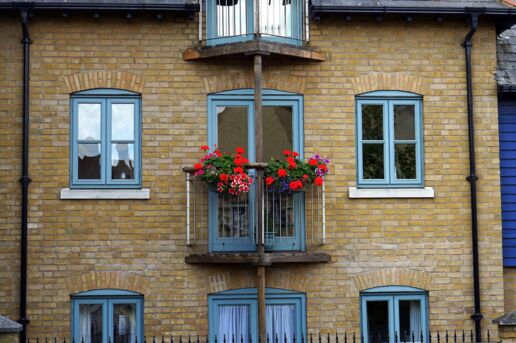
[349,187,435,199]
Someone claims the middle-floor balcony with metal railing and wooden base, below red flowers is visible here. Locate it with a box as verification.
[183,164,330,265]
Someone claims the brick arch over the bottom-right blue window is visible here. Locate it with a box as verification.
[353,268,432,291]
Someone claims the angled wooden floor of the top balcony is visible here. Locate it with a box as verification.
[183,39,326,62]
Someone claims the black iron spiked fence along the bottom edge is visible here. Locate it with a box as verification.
[27,330,498,343]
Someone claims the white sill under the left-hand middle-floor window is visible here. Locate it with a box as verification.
[60,188,150,200]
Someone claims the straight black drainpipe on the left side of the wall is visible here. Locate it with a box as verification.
[18,9,31,343]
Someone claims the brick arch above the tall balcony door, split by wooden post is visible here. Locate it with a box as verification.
[203,71,306,94]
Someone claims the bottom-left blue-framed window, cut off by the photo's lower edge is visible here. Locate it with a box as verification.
[72,289,143,343]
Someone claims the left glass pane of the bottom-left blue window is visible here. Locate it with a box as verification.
[79,304,102,343]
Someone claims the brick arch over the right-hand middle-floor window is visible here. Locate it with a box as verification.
[351,73,428,95]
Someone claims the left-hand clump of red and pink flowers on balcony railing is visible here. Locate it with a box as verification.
[194,145,253,196]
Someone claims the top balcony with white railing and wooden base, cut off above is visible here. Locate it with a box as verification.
[183,0,324,61]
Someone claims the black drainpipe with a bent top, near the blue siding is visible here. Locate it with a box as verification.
[462,13,483,342]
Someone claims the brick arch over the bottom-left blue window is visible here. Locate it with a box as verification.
[68,271,147,294]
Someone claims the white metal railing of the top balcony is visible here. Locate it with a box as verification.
[199,0,310,45]
